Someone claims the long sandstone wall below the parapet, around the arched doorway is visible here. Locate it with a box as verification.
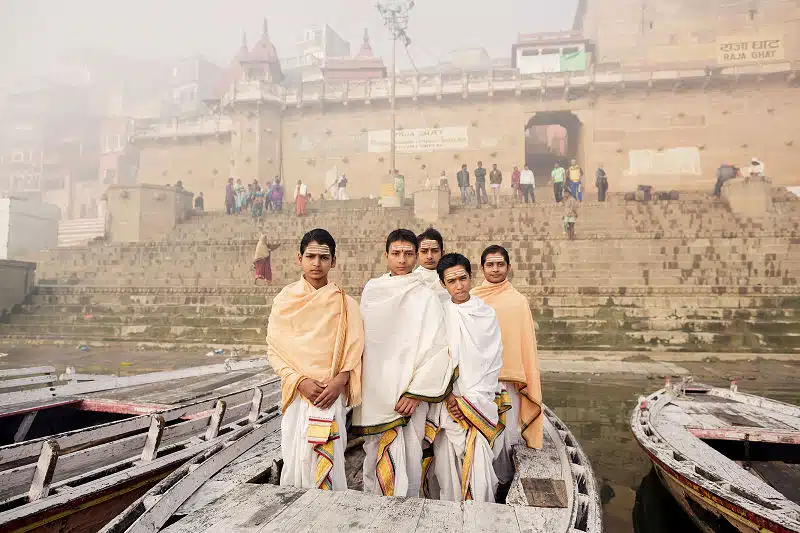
[140,80,800,202]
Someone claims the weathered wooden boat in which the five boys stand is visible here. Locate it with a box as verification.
[101,408,602,533]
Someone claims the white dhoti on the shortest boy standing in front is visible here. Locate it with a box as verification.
[433,409,497,502]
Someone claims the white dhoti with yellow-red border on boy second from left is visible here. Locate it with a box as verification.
[362,402,428,498]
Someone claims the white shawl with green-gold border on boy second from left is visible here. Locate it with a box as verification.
[353,273,453,435]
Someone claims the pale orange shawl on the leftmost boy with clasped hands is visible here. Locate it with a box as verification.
[267,278,364,412]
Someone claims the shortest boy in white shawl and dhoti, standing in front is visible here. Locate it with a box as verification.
[433,254,510,502]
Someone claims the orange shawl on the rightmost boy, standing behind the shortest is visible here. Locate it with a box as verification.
[472,280,543,448]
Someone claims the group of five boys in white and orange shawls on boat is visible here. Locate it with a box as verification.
[267,228,543,501]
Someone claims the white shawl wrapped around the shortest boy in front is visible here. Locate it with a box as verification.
[445,296,503,425]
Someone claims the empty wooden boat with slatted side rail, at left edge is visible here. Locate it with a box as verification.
[0,361,280,533]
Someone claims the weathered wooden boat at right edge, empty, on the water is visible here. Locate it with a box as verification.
[631,380,800,533]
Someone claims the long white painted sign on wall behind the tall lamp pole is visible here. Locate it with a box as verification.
[367,126,469,154]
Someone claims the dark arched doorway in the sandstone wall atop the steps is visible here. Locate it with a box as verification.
[525,111,581,186]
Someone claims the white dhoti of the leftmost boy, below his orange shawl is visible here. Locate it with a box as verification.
[281,396,347,490]
